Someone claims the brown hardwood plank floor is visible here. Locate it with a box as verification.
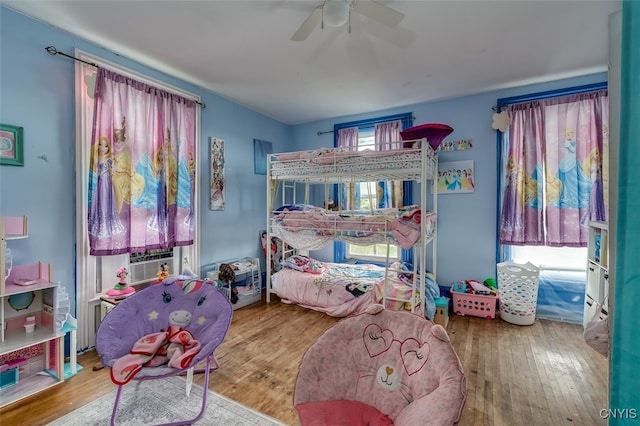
[0,301,608,426]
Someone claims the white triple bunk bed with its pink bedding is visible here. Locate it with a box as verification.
[265,138,438,317]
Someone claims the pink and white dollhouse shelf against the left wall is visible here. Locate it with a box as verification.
[0,216,70,407]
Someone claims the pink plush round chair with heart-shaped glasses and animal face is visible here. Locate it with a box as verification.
[293,305,467,426]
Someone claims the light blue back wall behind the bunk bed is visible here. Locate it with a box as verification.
[293,73,607,286]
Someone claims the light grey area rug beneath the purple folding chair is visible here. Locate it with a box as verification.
[49,377,284,426]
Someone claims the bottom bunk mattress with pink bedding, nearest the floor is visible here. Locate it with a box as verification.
[271,262,413,318]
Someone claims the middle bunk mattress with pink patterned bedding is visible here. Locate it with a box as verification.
[272,206,437,250]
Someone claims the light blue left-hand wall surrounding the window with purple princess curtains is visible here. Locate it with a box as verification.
[0,7,292,306]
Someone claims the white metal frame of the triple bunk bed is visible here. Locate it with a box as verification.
[265,138,438,315]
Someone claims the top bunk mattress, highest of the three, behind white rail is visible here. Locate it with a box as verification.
[270,148,436,177]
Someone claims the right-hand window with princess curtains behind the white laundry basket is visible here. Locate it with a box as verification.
[498,83,608,271]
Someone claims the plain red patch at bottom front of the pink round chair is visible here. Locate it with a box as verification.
[295,400,393,426]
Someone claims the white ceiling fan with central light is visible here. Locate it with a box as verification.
[291,0,404,41]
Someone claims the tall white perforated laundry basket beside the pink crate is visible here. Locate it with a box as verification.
[498,262,540,325]
